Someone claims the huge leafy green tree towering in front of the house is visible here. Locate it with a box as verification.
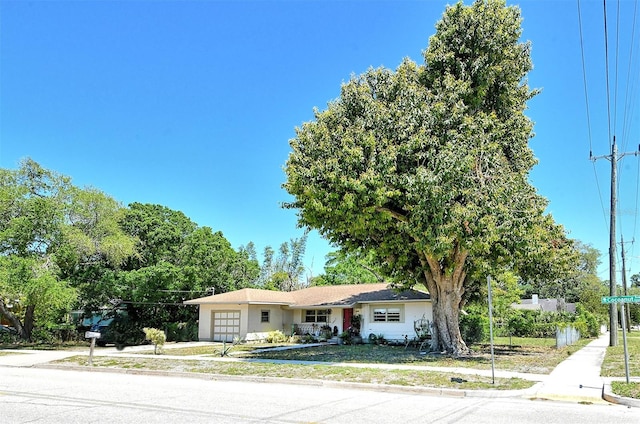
[284,0,570,355]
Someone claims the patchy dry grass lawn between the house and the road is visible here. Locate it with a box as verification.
[47,338,589,390]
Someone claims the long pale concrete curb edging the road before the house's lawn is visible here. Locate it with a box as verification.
[33,364,541,398]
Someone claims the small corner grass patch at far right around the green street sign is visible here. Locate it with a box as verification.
[601,330,640,399]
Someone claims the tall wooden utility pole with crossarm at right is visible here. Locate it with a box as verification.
[590,135,640,346]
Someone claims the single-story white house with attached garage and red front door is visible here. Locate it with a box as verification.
[184,283,432,341]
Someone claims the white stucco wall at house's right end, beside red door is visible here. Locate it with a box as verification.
[354,302,433,342]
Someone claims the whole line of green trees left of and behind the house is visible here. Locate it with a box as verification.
[0,159,307,339]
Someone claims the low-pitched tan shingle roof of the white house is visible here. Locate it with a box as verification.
[184,283,431,308]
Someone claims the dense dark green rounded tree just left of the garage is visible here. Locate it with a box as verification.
[116,203,258,336]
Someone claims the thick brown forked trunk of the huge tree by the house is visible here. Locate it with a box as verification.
[421,249,469,356]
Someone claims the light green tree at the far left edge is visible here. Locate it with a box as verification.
[0,159,135,339]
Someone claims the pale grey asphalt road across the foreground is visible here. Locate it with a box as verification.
[0,367,640,424]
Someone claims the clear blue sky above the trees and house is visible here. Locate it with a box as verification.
[0,0,640,284]
